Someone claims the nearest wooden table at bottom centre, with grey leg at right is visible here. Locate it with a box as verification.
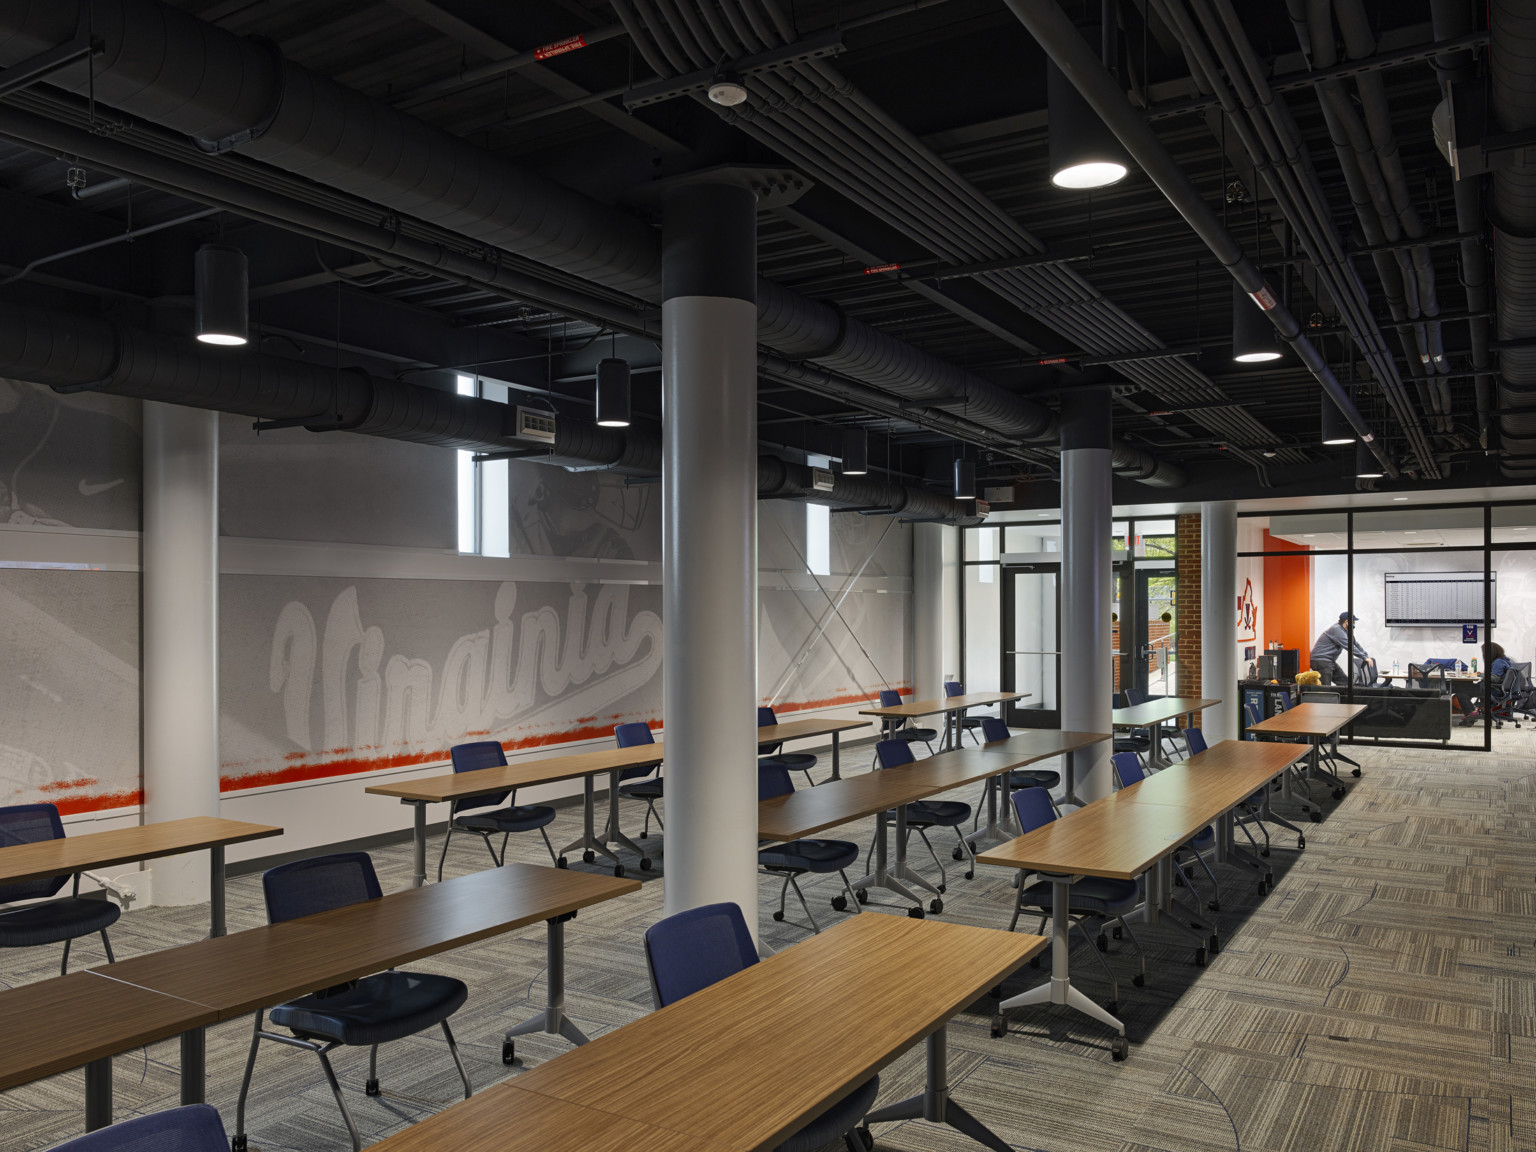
[509,909,1046,1152]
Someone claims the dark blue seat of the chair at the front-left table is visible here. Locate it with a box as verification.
[272,972,470,1044]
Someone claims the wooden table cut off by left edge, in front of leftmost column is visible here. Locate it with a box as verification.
[0,816,283,935]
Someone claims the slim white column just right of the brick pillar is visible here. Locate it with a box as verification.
[1200,501,1241,743]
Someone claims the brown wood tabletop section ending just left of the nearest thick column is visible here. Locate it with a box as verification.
[92,863,641,1020]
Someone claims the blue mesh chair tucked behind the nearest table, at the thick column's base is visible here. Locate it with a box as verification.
[645,903,880,1152]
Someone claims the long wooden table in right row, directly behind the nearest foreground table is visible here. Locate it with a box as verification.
[977,740,1301,1060]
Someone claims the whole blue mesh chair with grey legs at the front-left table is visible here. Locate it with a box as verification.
[230,854,470,1152]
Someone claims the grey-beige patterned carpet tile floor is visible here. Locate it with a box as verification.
[0,740,1536,1152]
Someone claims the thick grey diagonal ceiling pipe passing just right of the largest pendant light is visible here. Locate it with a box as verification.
[1006,0,1399,479]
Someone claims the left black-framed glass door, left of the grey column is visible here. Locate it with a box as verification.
[1001,564,1061,728]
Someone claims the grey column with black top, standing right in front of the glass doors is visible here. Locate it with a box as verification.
[1060,390,1115,800]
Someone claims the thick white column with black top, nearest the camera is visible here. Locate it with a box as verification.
[662,184,757,932]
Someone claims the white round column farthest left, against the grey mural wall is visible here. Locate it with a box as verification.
[141,401,218,905]
